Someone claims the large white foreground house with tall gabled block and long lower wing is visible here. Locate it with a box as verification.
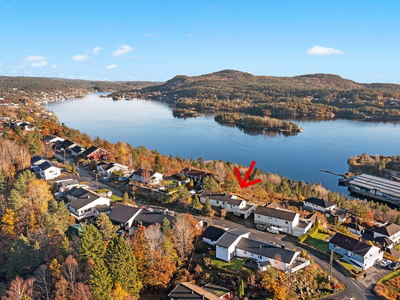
[215,229,310,273]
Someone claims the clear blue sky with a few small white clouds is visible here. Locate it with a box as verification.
[0,0,400,84]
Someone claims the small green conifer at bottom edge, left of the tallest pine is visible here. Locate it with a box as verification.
[89,258,112,300]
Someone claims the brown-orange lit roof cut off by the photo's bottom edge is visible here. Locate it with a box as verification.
[168,282,220,300]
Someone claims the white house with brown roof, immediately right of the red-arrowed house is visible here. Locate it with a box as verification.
[254,206,313,236]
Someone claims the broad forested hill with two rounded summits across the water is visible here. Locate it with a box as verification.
[143,70,400,101]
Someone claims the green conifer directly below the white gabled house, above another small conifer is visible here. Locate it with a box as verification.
[79,224,105,261]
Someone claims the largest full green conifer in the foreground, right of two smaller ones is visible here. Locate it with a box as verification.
[104,236,142,297]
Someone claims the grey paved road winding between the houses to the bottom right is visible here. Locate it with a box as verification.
[138,202,383,300]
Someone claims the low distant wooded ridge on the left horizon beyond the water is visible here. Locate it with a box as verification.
[0,76,160,93]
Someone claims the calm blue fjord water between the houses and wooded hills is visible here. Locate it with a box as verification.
[47,93,400,193]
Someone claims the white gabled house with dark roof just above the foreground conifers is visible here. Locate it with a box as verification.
[66,188,110,221]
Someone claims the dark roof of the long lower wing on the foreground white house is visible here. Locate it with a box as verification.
[236,238,296,264]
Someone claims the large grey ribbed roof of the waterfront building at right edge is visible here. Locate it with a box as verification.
[349,174,400,198]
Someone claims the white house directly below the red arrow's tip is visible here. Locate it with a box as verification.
[200,191,256,219]
